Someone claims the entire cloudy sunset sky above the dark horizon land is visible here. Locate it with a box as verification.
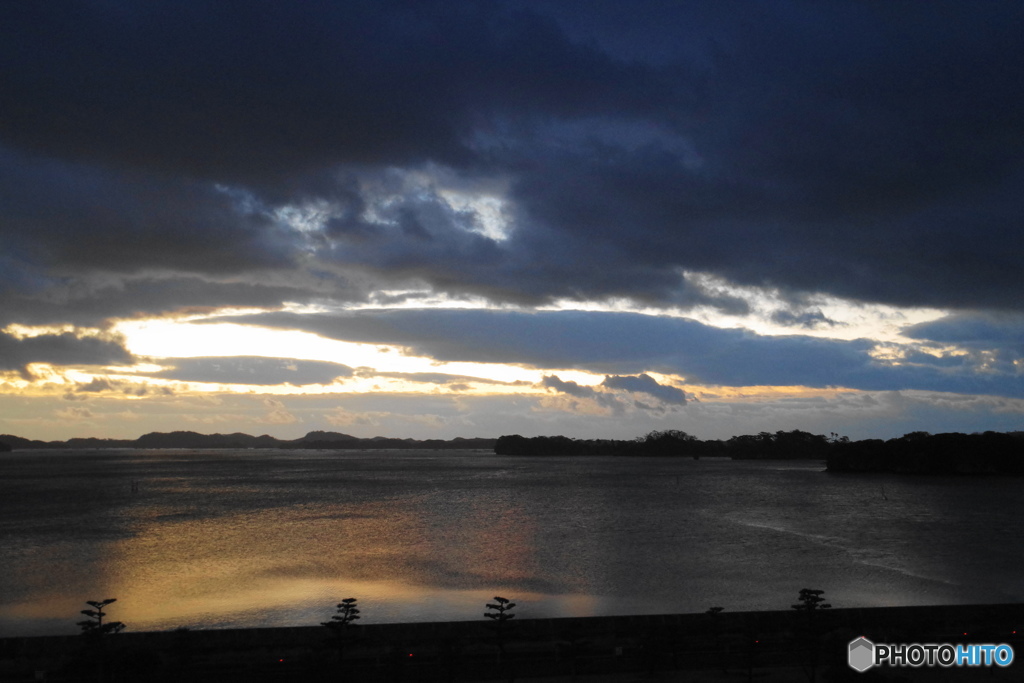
[0,0,1024,439]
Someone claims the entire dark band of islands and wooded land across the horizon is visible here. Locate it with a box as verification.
[8,429,1024,476]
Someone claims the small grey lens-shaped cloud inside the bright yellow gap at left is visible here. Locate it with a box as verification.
[151,356,352,386]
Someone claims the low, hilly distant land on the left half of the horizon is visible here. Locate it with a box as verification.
[0,431,496,451]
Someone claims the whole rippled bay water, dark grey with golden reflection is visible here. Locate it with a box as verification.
[0,450,1024,636]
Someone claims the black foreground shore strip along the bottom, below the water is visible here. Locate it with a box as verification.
[0,603,1024,682]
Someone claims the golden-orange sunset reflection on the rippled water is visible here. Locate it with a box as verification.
[64,489,565,630]
